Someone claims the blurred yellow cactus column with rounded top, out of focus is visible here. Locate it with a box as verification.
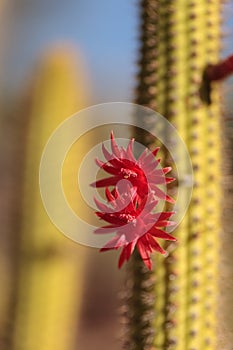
[12,47,90,350]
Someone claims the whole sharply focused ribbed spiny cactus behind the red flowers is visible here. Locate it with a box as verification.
[125,0,221,350]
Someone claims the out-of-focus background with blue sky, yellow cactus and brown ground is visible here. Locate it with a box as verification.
[0,0,233,350]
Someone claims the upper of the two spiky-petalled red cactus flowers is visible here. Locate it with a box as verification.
[91,132,174,203]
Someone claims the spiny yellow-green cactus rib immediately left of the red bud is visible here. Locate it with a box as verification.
[186,2,211,349]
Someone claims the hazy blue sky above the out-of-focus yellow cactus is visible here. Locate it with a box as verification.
[4,0,233,103]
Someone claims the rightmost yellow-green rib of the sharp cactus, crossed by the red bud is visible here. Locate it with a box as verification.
[204,1,223,350]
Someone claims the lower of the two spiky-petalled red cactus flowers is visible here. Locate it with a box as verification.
[95,188,176,269]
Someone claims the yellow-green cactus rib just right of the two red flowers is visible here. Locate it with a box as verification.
[158,1,189,349]
